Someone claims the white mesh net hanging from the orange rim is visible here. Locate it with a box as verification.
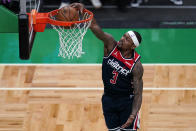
[52,13,91,59]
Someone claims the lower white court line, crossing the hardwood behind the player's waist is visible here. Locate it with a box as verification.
[0,87,196,91]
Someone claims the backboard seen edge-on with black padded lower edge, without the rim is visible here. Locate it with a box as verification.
[18,0,42,59]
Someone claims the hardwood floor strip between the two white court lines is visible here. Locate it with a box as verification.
[0,65,196,88]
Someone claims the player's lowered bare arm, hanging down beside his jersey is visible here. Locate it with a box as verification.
[122,61,144,128]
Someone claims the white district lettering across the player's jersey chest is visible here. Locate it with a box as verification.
[108,59,130,76]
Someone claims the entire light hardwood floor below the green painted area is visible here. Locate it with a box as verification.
[0,65,196,131]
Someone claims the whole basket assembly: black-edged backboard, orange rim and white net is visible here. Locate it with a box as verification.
[19,0,93,59]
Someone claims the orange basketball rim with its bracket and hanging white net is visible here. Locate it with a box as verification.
[28,9,93,59]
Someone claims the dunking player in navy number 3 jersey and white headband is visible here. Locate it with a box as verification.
[71,3,143,131]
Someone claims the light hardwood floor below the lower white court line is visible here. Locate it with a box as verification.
[0,90,196,131]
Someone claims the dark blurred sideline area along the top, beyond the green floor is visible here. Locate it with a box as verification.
[1,0,196,28]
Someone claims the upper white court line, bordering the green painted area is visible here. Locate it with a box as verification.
[0,63,196,66]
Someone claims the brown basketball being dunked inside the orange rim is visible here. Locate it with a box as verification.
[56,6,79,22]
